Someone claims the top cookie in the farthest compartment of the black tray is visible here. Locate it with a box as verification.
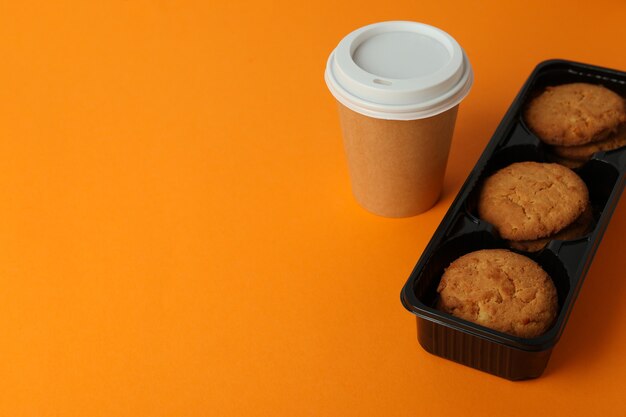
[524,83,626,146]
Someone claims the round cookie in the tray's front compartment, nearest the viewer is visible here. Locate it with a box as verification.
[437,249,558,338]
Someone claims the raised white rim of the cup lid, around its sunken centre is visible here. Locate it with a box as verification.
[324,21,474,120]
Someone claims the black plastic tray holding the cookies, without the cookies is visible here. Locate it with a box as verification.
[401,60,626,380]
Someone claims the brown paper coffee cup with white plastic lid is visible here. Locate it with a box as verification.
[325,21,473,217]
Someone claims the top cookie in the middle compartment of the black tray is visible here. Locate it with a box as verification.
[478,162,589,240]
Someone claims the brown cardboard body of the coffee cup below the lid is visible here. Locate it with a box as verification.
[339,103,458,217]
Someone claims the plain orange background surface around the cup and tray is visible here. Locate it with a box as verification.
[0,0,626,417]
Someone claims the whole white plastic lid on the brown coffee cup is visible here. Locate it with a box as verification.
[324,21,474,120]
